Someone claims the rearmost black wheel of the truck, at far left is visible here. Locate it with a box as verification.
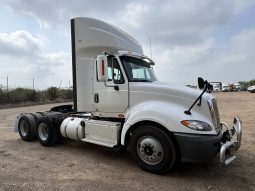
[18,114,36,142]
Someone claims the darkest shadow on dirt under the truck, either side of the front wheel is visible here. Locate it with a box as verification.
[58,140,236,179]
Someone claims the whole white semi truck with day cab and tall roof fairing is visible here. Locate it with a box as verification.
[15,18,242,173]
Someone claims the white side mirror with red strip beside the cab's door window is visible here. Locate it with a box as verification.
[96,55,108,82]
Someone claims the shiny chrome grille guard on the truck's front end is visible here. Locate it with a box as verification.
[220,116,242,165]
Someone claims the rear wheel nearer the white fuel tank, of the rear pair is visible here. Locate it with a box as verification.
[36,117,58,147]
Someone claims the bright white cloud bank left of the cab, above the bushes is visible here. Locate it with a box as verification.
[0,31,71,88]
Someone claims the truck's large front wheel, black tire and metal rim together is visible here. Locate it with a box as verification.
[130,125,177,174]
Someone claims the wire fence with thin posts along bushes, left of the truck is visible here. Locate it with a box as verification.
[0,76,73,104]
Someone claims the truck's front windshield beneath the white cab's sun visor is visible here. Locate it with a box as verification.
[120,56,157,82]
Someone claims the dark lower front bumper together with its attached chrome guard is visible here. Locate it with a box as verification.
[174,116,242,165]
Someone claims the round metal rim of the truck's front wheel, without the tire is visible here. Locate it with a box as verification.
[137,136,164,165]
